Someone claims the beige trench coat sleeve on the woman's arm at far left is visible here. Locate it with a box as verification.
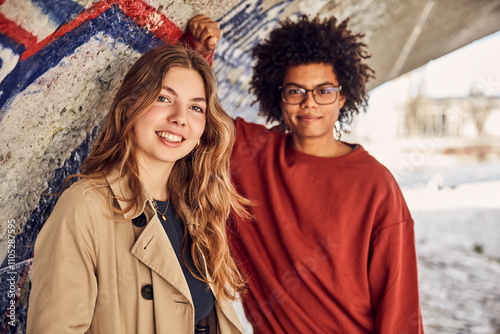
[27,187,97,334]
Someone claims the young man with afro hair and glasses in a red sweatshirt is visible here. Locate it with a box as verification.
[190,16,423,334]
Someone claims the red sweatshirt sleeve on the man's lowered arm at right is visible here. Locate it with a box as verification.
[368,220,423,334]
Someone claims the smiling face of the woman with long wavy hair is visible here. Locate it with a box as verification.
[134,67,208,166]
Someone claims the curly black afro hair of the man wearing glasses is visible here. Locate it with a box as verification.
[250,15,375,131]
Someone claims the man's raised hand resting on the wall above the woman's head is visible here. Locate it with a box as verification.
[188,14,222,54]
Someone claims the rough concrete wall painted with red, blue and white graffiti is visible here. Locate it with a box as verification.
[0,0,288,333]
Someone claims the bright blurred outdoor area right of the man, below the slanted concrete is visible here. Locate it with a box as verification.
[345,33,500,334]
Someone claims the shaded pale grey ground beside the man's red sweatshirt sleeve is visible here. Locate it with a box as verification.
[408,185,500,334]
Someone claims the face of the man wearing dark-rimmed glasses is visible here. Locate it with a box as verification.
[280,64,345,141]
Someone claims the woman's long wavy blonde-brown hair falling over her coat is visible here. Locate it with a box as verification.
[80,45,248,300]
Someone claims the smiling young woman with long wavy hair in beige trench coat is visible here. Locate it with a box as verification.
[27,45,249,334]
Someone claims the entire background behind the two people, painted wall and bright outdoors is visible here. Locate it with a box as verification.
[0,0,500,334]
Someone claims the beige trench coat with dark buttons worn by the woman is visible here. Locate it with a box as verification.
[27,174,243,334]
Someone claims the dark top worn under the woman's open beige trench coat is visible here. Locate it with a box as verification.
[156,201,215,324]
